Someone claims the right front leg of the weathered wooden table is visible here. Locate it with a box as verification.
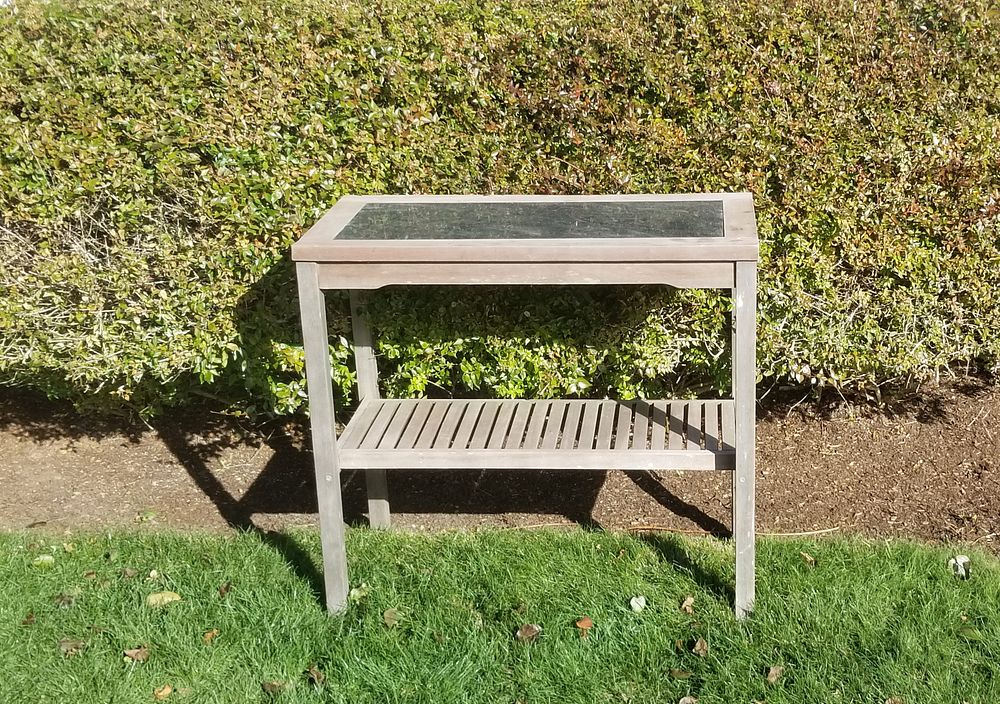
[733,262,757,618]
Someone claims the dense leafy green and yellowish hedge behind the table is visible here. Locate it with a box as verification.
[0,0,1000,413]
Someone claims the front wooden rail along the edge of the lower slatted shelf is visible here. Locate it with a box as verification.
[341,448,734,471]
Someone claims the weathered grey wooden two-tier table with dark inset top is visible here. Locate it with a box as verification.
[292,193,758,616]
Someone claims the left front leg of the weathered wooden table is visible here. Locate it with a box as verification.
[296,262,347,613]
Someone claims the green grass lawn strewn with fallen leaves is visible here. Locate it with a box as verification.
[0,530,1000,704]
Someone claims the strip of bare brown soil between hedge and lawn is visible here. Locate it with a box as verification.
[0,379,1000,549]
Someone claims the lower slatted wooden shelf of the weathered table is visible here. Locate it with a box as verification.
[337,399,735,470]
